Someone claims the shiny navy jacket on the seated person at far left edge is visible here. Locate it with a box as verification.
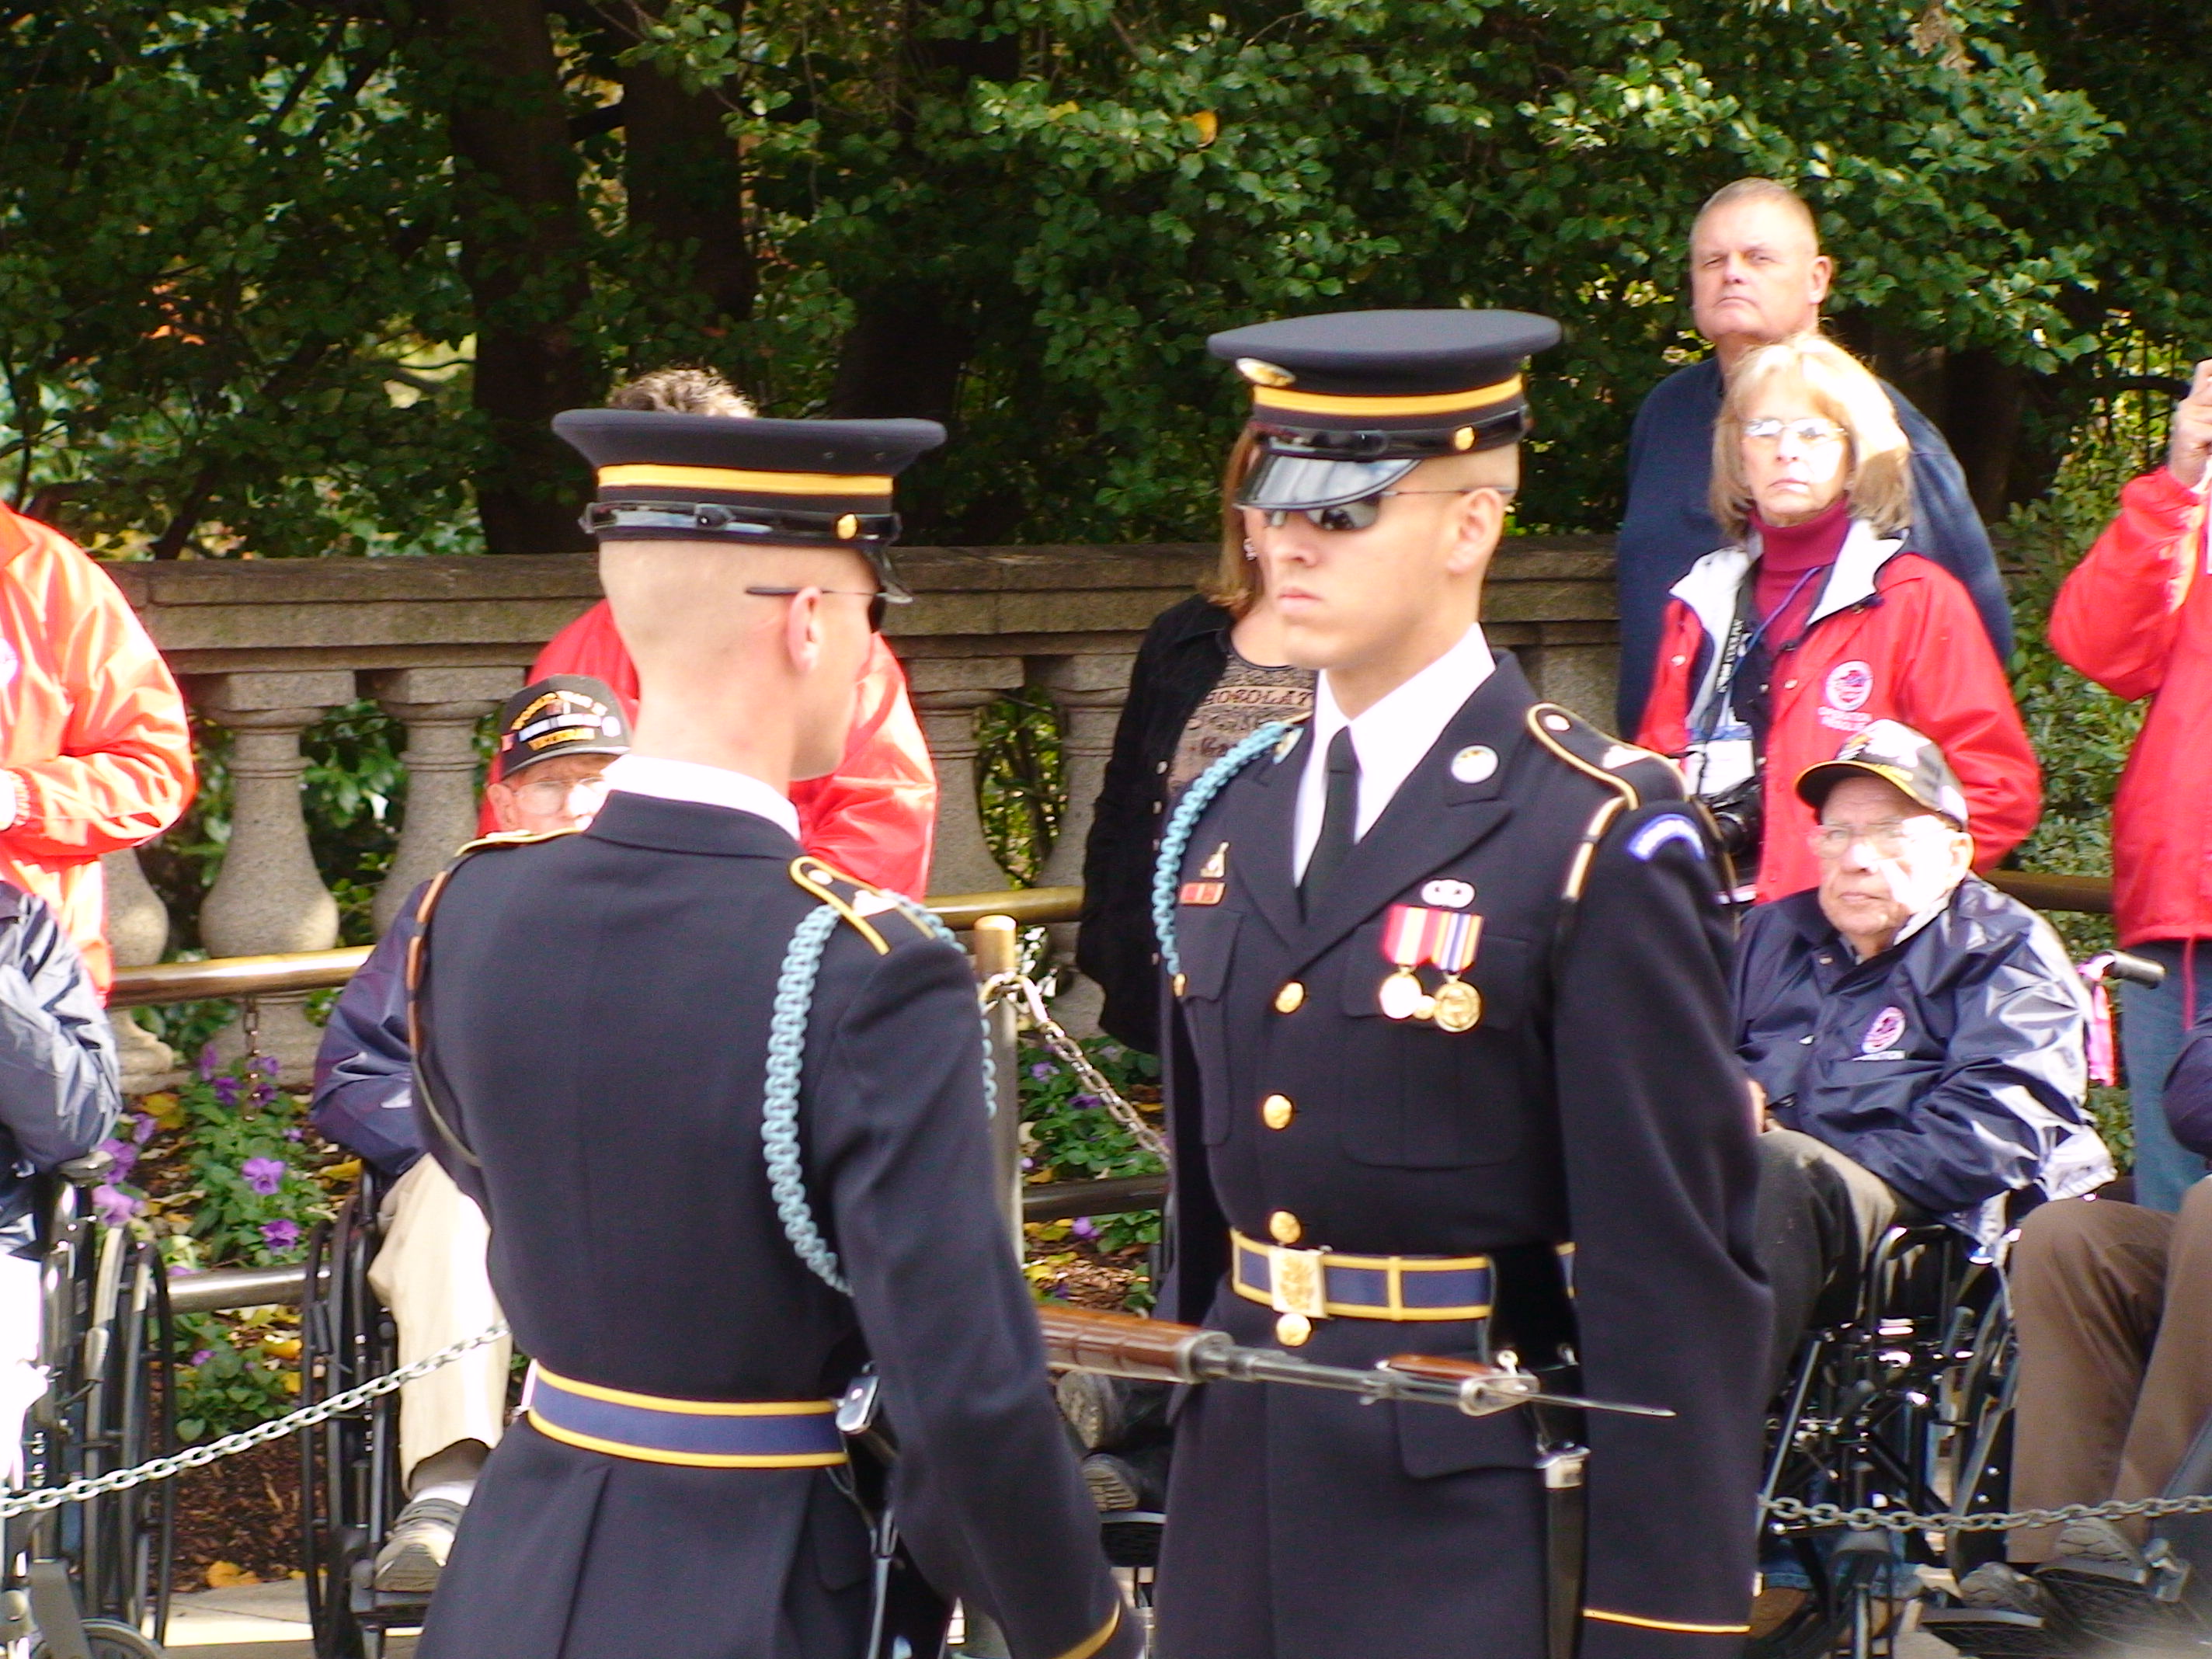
[0,881,122,1257]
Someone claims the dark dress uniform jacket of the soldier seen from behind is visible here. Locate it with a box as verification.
[418,790,1137,1659]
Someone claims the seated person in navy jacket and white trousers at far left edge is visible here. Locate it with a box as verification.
[0,881,122,1482]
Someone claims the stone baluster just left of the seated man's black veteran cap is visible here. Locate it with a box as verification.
[370,668,522,934]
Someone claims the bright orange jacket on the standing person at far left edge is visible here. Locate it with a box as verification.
[0,506,193,993]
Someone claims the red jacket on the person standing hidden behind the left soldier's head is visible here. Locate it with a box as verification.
[513,600,938,896]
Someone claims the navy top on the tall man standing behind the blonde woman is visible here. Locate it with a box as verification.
[1615,358,2013,732]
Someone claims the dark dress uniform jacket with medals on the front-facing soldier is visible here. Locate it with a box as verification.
[1159,657,1768,1659]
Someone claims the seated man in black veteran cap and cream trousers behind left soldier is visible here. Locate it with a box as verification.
[312,675,631,1597]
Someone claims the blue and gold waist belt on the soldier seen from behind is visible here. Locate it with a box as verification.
[522,1362,845,1469]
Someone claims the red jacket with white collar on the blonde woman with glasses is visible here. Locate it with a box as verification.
[1637,522,2044,903]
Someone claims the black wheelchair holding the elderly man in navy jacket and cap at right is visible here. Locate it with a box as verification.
[1748,1226,2017,1659]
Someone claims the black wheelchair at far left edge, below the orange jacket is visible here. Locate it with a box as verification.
[0,1155,177,1659]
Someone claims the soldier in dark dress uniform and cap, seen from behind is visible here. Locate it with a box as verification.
[412,409,1139,1659]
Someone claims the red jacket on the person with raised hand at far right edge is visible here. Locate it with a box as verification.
[2050,467,2212,944]
